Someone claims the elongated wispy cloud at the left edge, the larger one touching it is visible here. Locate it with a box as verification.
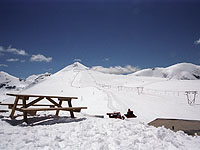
[0,45,28,56]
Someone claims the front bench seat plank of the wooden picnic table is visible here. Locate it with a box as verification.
[20,107,87,112]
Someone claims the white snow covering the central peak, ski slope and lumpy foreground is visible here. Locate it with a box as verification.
[0,63,200,149]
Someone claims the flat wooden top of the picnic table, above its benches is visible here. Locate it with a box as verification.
[6,93,78,99]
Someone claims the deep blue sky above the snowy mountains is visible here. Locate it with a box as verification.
[0,0,200,77]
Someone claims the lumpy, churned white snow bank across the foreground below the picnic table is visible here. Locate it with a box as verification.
[0,118,200,150]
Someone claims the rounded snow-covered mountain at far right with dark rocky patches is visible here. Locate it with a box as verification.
[132,63,200,80]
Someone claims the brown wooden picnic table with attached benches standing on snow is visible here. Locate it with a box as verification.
[4,93,87,123]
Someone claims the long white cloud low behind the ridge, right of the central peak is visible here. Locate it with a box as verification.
[91,65,140,74]
